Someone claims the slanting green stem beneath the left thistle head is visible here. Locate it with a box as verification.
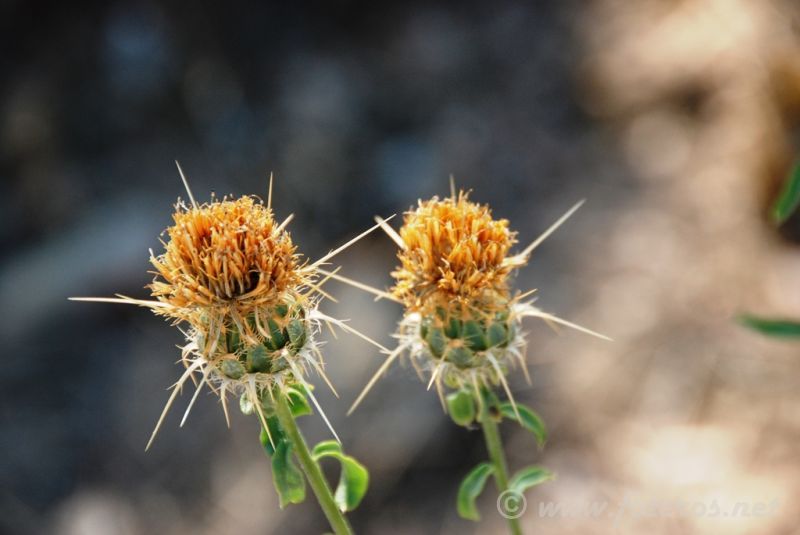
[275,395,353,535]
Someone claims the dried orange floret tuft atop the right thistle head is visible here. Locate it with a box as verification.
[392,192,520,312]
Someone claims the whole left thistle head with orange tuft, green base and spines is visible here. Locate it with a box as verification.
[72,167,388,448]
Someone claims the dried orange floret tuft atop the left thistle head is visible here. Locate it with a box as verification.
[150,197,302,310]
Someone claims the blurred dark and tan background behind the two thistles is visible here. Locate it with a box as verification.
[0,0,800,535]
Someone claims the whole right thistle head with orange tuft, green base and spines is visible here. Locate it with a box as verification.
[344,188,606,411]
